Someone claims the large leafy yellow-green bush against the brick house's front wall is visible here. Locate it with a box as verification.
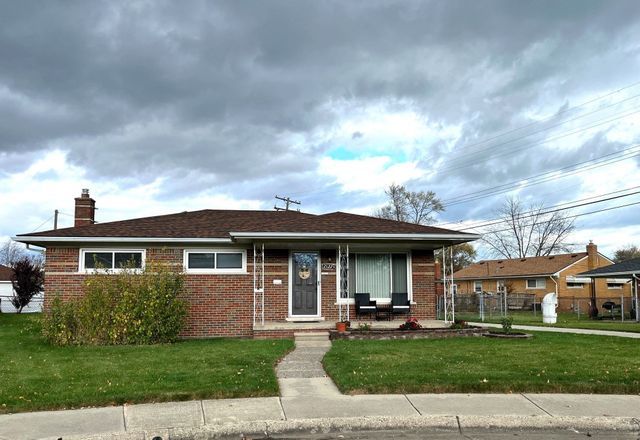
[43,264,187,345]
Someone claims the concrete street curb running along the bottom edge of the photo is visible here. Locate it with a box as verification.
[56,416,640,440]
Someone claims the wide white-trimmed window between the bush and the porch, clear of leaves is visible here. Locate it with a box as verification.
[184,249,247,273]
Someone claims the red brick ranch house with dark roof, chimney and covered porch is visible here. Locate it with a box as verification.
[15,190,478,337]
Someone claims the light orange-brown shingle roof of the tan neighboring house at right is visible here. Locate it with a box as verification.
[453,252,587,279]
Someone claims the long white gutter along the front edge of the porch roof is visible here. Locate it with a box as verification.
[229,232,480,241]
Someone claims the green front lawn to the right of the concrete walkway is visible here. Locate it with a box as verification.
[323,333,640,394]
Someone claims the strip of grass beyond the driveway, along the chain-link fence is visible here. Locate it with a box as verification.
[456,312,640,333]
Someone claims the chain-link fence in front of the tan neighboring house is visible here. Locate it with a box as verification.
[436,293,636,323]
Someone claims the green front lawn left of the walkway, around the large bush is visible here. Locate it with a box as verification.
[0,314,293,413]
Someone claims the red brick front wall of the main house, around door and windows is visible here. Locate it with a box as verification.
[45,247,436,337]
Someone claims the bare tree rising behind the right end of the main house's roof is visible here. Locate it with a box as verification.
[374,184,444,225]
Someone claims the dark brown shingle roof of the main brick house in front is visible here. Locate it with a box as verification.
[18,209,475,239]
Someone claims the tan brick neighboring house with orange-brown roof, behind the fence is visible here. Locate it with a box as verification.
[453,243,631,300]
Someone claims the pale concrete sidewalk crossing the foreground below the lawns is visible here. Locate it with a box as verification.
[0,393,640,440]
